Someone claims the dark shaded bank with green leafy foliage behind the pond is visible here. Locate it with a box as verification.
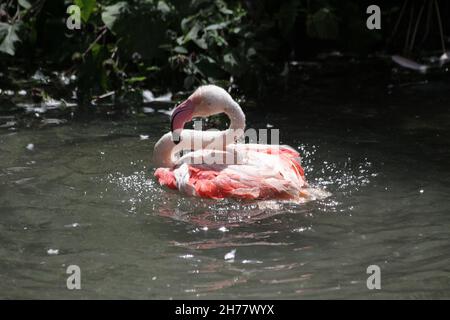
[0,0,450,114]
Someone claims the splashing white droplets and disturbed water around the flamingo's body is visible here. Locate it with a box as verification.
[102,145,377,224]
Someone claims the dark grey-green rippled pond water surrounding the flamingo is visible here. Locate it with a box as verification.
[0,78,450,299]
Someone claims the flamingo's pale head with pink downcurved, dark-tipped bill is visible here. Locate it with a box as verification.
[170,85,233,144]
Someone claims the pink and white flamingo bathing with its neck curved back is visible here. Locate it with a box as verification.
[153,85,308,200]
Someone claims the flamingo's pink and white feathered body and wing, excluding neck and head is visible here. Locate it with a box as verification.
[155,144,306,199]
